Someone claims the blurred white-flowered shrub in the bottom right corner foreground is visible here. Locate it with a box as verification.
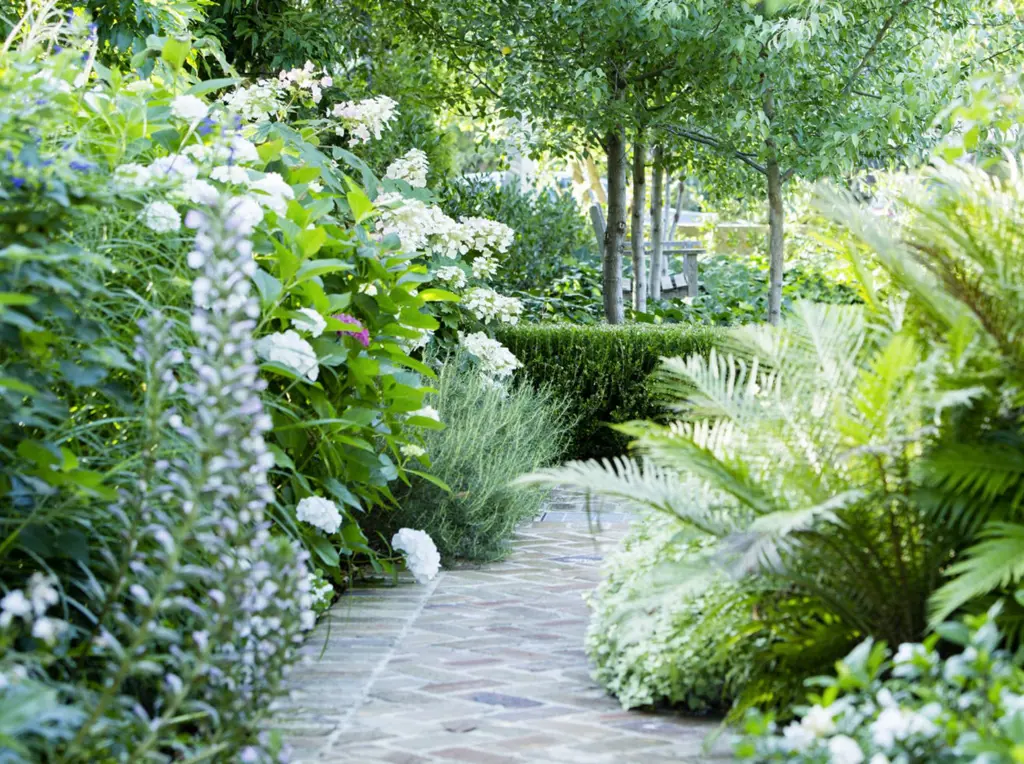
[736,608,1024,764]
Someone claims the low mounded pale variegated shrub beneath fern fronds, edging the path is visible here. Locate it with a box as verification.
[587,513,751,711]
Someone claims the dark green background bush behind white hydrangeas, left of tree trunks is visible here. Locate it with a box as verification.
[438,180,598,296]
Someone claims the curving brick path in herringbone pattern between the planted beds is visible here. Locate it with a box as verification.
[274,498,730,764]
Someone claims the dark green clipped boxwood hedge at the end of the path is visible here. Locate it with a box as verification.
[498,324,716,459]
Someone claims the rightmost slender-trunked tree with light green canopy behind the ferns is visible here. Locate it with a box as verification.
[666,0,1009,324]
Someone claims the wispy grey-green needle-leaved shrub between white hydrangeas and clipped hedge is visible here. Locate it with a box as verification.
[386,354,568,560]
